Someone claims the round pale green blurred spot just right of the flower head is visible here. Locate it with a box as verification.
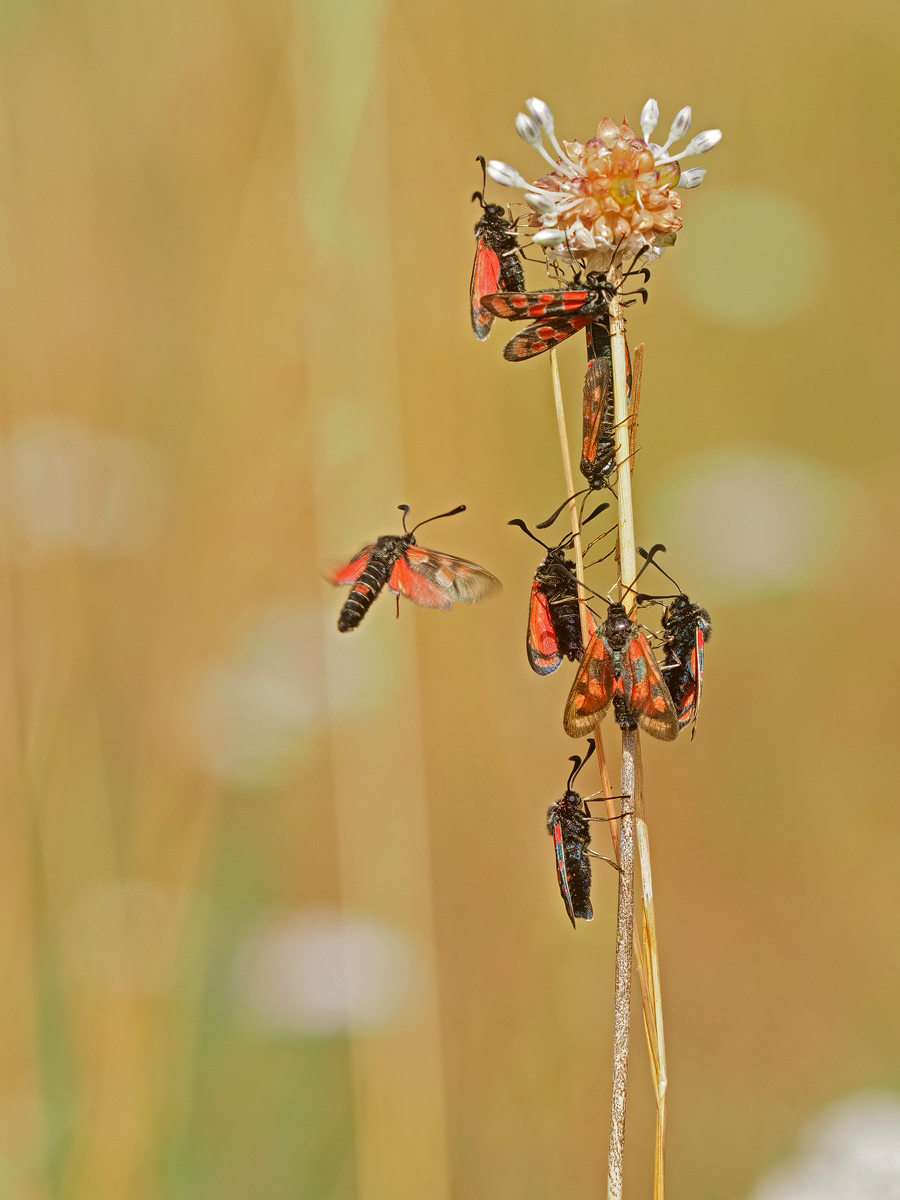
[673,190,822,325]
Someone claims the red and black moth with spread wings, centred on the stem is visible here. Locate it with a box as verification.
[563,604,678,742]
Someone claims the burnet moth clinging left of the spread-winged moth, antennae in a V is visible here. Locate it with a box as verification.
[508,504,610,674]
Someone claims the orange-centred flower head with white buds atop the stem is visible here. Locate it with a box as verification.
[487,97,721,270]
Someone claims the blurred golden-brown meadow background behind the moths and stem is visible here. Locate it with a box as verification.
[0,0,900,1200]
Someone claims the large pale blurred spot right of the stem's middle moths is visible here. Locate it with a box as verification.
[648,450,868,602]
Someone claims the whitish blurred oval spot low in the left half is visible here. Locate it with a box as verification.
[238,908,425,1037]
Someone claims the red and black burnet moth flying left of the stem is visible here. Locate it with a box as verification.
[331,504,502,634]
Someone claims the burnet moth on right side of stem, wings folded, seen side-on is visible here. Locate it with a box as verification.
[637,542,713,739]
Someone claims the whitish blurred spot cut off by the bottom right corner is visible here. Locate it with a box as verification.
[750,1092,900,1200]
